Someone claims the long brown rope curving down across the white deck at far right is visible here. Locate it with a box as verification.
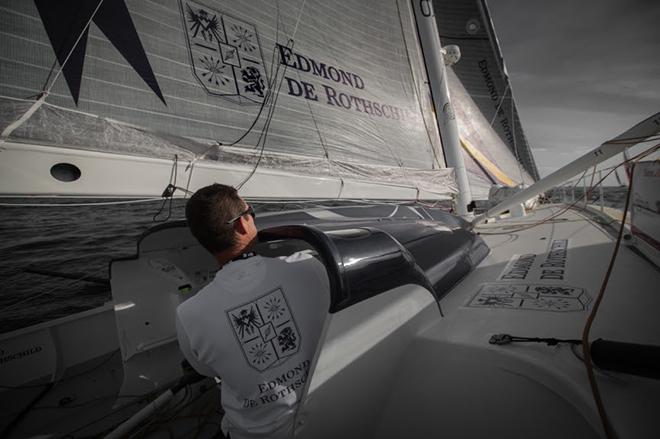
[582,161,636,439]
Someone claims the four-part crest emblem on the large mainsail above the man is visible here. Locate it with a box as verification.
[180,0,268,104]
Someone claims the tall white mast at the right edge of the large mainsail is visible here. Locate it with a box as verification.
[413,0,472,216]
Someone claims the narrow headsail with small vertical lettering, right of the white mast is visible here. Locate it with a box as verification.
[433,0,539,196]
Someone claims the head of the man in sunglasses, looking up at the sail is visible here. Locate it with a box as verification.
[186,183,257,259]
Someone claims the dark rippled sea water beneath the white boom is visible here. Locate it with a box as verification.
[0,187,626,333]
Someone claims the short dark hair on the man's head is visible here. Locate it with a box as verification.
[186,183,245,254]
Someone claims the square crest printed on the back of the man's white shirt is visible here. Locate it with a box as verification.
[227,288,300,371]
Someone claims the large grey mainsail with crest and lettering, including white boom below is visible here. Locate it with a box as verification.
[0,0,456,199]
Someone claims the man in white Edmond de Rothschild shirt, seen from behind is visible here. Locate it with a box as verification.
[176,183,329,439]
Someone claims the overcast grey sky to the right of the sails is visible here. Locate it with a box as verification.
[488,0,660,176]
